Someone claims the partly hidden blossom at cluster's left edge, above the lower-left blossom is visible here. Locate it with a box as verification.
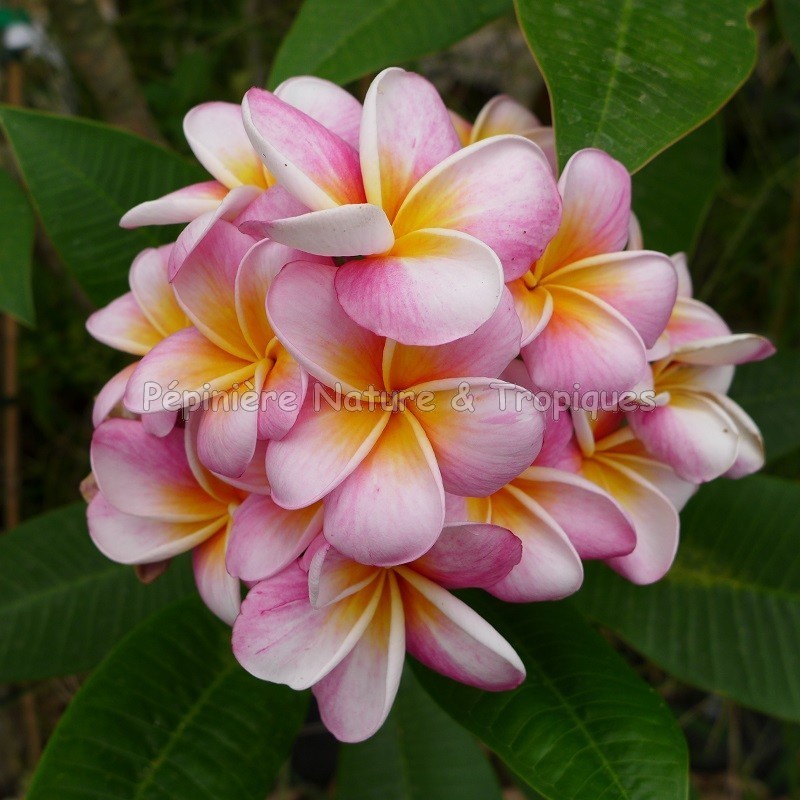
[86,245,191,434]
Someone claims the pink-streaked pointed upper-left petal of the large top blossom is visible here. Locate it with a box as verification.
[242,89,366,211]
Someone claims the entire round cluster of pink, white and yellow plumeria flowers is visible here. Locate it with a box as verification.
[85,68,772,741]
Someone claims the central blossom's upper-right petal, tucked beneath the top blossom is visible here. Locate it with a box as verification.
[383,291,520,389]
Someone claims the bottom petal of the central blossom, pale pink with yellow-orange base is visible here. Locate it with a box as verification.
[325,412,444,566]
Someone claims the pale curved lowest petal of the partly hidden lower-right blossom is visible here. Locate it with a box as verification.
[582,456,680,585]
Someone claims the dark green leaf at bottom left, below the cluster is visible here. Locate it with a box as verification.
[28,597,308,800]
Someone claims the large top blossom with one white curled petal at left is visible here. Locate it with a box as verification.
[243,68,560,345]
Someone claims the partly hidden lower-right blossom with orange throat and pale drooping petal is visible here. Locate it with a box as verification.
[572,409,695,584]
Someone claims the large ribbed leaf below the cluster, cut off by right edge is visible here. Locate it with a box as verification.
[577,476,800,720]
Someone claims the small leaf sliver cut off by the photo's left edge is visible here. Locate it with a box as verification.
[0,170,35,325]
